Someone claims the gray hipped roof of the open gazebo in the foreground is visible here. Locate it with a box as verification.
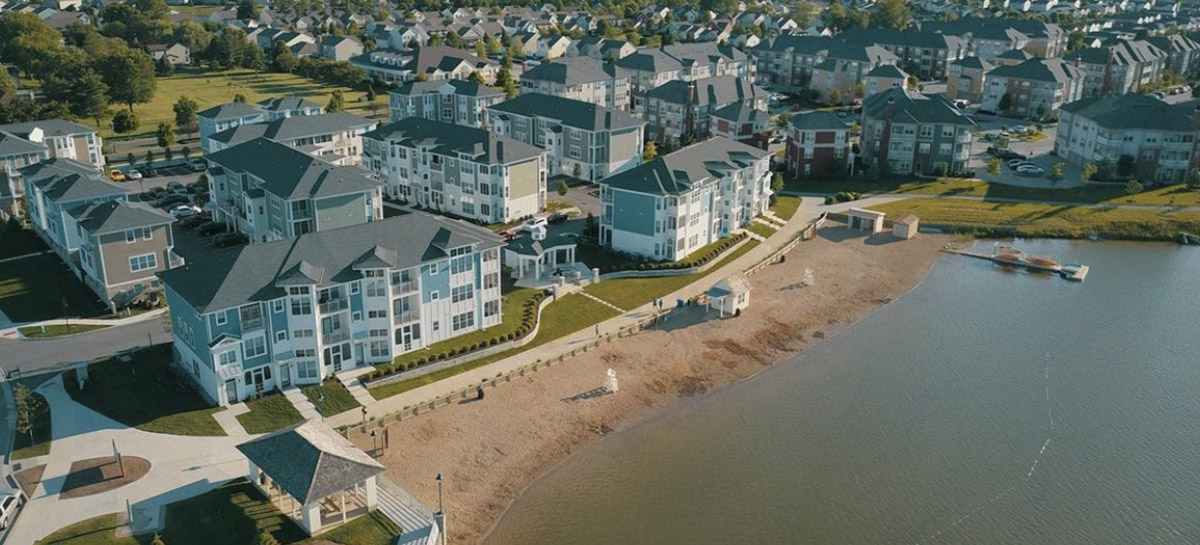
[238,420,384,504]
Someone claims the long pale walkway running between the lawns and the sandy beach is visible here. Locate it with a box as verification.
[325,196,904,427]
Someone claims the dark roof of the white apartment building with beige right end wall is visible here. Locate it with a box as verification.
[362,118,546,164]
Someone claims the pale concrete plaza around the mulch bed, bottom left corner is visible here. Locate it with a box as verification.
[7,377,247,545]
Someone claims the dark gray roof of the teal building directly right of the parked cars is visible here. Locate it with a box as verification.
[201,137,383,200]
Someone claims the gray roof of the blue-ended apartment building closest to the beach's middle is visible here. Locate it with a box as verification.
[600,137,767,196]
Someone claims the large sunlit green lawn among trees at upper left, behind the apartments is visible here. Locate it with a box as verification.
[109,68,388,141]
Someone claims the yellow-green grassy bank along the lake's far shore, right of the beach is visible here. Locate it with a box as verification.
[871,199,1200,240]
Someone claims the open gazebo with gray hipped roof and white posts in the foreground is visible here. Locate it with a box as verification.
[238,420,384,535]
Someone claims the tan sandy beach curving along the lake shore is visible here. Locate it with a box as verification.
[355,227,950,545]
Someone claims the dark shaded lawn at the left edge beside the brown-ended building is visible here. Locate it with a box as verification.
[0,253,108,323]
